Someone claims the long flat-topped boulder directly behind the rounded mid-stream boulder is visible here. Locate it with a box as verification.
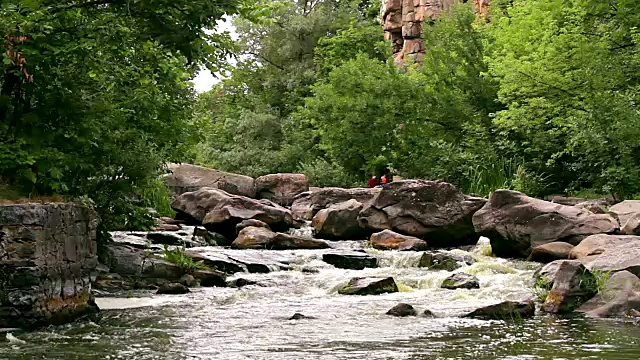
[291,187,380,220]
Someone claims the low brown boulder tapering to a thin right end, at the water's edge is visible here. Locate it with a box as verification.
[231,226,329,250]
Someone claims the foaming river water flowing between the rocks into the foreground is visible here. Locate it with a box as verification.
[0,238,640,360]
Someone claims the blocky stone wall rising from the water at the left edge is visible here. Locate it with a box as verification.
[0,204,98,328]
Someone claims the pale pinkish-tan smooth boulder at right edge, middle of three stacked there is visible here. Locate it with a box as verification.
[569,234,640,276]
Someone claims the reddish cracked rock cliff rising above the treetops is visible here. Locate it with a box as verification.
[380,0,489,63]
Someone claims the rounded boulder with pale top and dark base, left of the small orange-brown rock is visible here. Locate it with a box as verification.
[311,199,367,240]
